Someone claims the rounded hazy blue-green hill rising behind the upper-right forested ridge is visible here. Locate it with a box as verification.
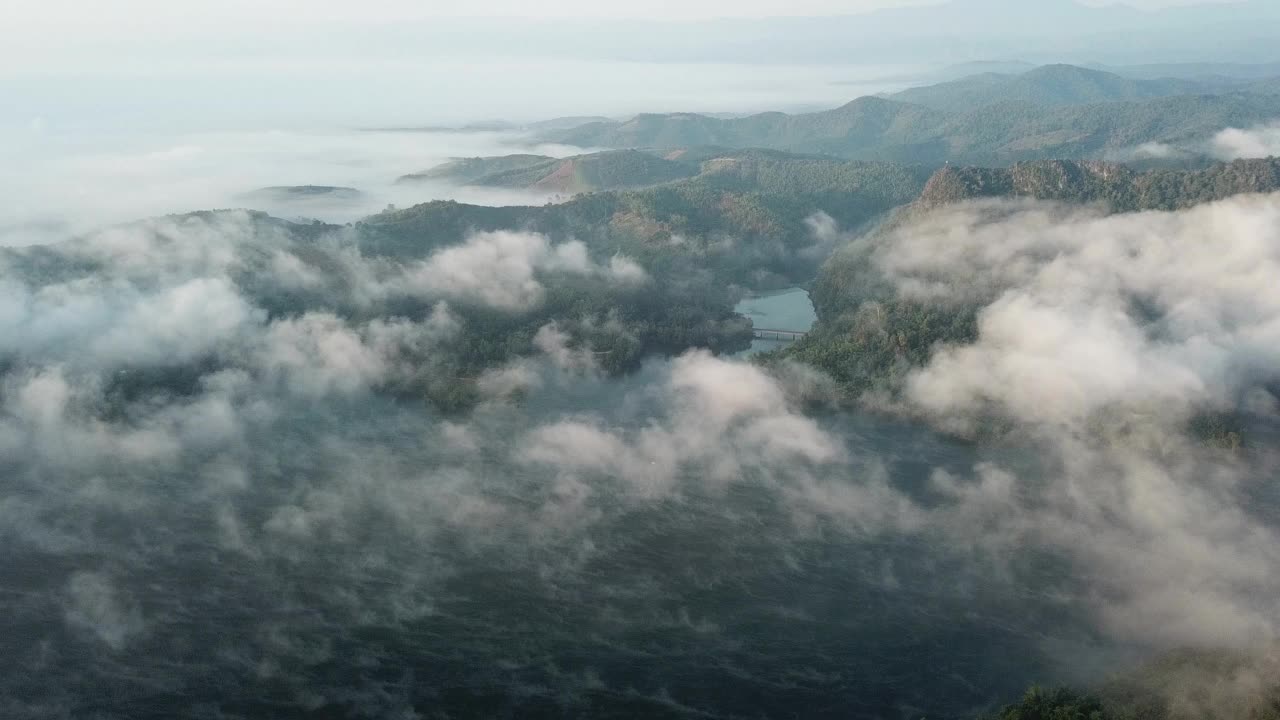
[890,65,1235,113]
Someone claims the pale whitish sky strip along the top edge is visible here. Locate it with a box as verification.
[0,0,1254,78]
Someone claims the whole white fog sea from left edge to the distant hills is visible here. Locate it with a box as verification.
[0,60,909,245]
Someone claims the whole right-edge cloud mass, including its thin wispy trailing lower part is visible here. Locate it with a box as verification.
[877,195,1280,647]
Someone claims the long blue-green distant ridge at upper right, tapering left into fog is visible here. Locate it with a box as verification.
[544,67,1280,165]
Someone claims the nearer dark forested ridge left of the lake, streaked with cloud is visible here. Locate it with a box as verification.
[0,206,750,410]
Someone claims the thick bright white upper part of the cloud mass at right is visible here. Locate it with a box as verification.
[877,196,1280,427]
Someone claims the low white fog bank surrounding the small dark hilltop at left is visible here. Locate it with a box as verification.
[0,127,580,246]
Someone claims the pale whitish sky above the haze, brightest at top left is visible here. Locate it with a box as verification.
[0,0,1231,69]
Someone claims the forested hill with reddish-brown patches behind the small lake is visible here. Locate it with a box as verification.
[356,147,929,283]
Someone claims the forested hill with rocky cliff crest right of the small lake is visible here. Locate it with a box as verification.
[783,159,1280,417]
